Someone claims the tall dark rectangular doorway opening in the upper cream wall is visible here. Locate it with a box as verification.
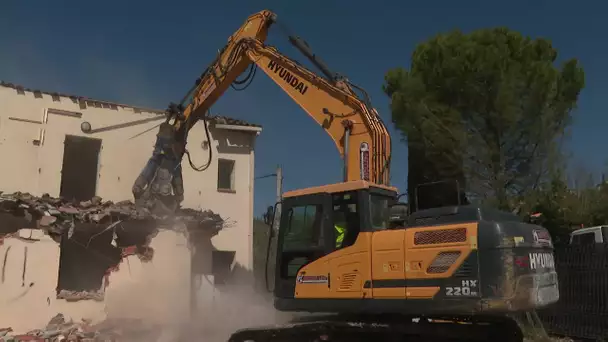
[59,134,101,201]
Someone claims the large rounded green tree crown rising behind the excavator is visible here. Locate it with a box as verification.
[383,28,584,209]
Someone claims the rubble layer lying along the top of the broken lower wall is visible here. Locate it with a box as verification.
[0,192,228,234]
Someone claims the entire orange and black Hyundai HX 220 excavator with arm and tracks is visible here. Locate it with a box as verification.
[134,10,559,341]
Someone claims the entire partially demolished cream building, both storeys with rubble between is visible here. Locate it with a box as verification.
[0,83,261,331]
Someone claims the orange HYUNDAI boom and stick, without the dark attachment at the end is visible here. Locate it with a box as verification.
[175,11,391,185]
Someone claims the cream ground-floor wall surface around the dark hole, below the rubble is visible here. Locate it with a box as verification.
[0,229,191,333]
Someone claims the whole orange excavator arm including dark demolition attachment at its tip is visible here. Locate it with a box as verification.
[133,10,391,210]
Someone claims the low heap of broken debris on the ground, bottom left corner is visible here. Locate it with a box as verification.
[0,314,161,342]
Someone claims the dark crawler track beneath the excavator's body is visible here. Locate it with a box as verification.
[228,315,523,342]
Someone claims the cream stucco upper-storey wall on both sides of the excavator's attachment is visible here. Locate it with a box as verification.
[0,86,256,269]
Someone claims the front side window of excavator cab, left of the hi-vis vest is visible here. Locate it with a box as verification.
[283,205,322,250]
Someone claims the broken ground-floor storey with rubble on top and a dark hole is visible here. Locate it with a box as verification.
[0,193,264,333]
